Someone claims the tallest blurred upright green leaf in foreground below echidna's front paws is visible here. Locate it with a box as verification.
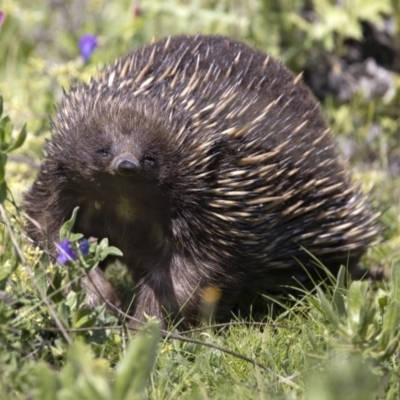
[113,321,160,400]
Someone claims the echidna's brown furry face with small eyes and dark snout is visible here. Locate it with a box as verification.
[49,97,177,194]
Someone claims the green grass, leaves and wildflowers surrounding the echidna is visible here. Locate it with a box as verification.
[0,0,400,400]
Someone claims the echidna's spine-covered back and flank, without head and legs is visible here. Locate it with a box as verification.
[95,36,378,274]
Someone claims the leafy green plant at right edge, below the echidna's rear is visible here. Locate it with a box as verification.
[317,265,400,362]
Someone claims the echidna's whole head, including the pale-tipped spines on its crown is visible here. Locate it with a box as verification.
[48,90,185,200]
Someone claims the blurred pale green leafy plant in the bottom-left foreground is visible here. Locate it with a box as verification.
[33,321,160,400]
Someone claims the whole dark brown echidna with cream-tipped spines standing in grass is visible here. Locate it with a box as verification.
[25,36,377,321]
